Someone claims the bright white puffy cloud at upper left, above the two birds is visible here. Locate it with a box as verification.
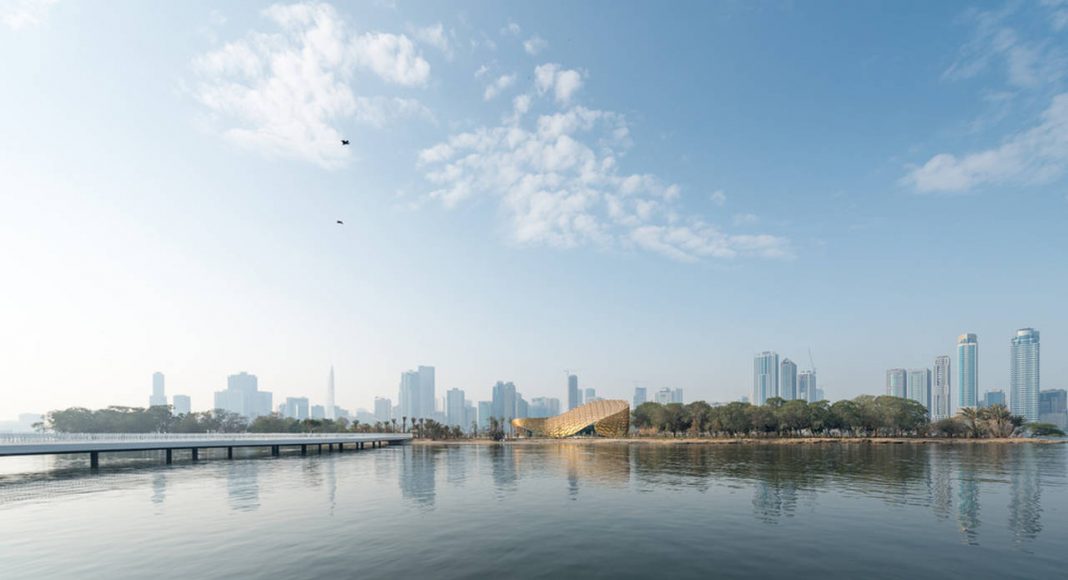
[193,3,430,167]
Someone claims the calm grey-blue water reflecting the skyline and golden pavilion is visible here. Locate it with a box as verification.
[0,444,1068,580]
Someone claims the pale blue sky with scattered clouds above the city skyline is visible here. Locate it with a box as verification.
[0,0,1068,417]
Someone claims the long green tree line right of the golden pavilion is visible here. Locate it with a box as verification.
[631,395,1063,438]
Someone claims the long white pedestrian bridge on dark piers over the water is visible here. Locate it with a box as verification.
[0,433,411,468]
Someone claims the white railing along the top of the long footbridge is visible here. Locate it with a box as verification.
[0,433,411,445]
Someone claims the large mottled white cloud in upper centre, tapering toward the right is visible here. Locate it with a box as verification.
[419,79,790,261]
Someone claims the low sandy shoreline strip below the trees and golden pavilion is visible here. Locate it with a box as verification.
[411,437,1068,446]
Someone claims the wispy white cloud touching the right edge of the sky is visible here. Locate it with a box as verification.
[904,93,1068,192]
